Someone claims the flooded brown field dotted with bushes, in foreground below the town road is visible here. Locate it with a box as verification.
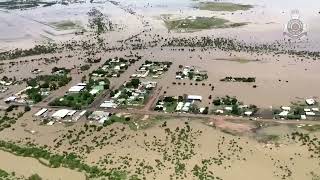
[0,112,320,180]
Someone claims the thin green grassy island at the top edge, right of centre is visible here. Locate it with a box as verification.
[198,2,253,12]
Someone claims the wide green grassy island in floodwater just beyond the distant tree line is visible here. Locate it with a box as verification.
[165,17,246,30]
